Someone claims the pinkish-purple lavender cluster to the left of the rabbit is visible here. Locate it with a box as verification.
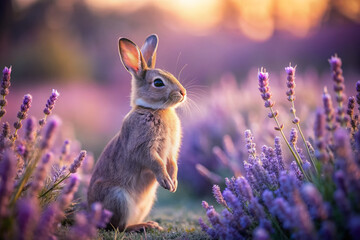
[0,68,111,240]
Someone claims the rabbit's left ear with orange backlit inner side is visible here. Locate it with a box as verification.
[119,38,147,75]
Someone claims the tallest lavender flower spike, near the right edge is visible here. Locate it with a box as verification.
[329,54,347,127]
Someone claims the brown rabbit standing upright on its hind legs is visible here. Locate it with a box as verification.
[88,34,186,231]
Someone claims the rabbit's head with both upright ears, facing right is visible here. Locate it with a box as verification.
[119,34,186,109]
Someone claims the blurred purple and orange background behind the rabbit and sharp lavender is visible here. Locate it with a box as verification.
[0,0,360,200]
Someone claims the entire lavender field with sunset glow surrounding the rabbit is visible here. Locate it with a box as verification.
[0,0,360,240]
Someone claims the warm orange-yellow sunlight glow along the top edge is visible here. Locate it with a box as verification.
[14,0,360,41]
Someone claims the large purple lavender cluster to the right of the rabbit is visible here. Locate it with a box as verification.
[199,54,360,240]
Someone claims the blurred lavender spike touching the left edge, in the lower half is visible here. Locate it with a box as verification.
[0,150,16,217]
